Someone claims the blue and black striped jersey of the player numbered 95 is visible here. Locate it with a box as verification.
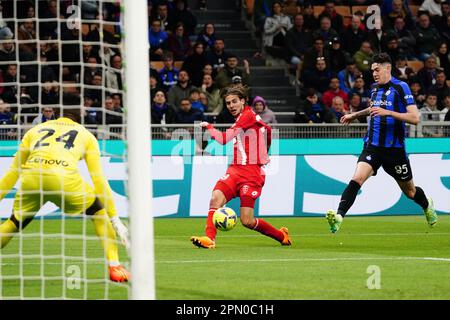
[364,77,416,148]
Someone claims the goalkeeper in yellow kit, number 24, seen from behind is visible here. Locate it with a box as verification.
[0,108,130,282]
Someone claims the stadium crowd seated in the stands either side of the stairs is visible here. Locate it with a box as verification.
[0,0,450,135]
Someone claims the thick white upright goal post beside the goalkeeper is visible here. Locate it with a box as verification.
[122,0,155,300]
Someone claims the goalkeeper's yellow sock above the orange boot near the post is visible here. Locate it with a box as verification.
[92,209,119,264]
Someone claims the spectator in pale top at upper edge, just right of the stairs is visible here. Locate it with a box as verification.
[263,1,292,60]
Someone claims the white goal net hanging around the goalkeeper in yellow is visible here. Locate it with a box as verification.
[0,0,153,300]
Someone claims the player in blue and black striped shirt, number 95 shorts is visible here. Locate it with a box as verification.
[326,53,437,233]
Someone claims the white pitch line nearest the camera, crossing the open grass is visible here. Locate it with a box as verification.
[156,257,450,264]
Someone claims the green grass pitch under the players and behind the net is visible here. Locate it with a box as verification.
[1,215,450,300]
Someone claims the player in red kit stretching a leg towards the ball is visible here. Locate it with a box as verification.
[191,85,291,249]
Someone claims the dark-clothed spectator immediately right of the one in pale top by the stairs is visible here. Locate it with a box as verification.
[286,14,312,66]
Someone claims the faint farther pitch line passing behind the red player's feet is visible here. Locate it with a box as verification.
[155,232,450,239]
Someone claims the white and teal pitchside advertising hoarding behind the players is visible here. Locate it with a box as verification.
[0,139,450,217]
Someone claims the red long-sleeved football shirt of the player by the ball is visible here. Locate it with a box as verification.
[207,106,272,166]
